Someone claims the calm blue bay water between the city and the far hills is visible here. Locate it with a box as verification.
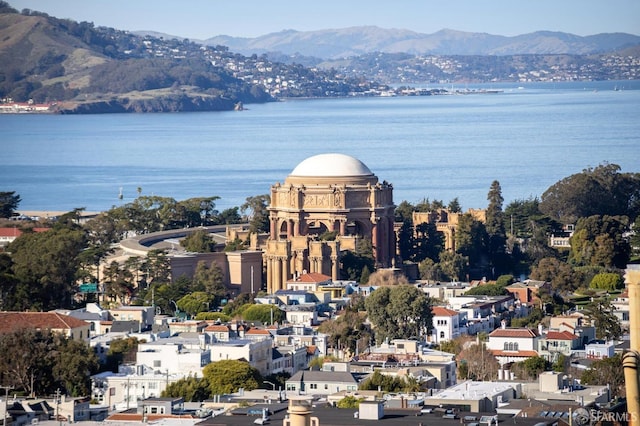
[0,81,640,211]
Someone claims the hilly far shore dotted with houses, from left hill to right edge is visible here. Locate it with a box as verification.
[0,2,640,113]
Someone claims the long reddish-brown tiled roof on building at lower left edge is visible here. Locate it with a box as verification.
[0,312,89,333]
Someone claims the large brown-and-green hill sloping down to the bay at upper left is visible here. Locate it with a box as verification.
[0,1,376,113]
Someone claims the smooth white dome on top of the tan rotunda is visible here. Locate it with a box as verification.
[291,153,373,177]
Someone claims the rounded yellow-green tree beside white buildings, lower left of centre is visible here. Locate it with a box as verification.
[202,359,262,395]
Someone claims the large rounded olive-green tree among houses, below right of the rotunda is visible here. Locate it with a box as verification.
[365,285,433,342]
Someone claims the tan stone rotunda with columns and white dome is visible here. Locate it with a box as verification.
[265,153,395,293]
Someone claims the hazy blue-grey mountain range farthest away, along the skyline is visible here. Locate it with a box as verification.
[186,26,640,59]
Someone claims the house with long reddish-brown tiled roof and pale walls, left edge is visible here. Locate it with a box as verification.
[0,312,91,342]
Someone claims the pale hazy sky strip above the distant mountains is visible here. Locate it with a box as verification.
[7,0,640,39]
